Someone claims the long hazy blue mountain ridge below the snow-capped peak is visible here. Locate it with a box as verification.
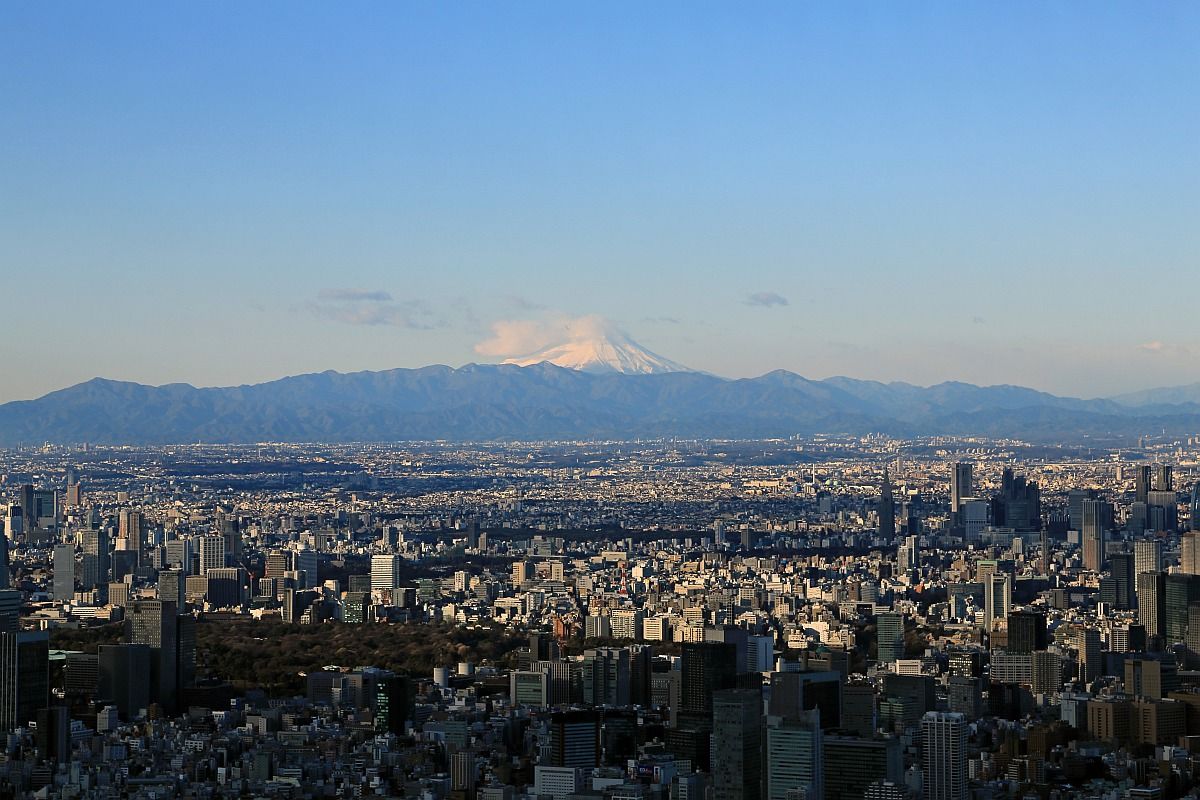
[0,362,1200,446]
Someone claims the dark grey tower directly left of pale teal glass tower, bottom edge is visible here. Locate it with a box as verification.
[709,688,762,800]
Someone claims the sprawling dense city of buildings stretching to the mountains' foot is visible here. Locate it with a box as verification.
[7,435,1200,800]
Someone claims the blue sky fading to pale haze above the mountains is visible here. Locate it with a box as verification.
[0,1,1200,401]
